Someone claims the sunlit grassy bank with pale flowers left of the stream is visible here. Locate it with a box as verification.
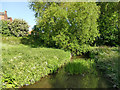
[1,37,70,88]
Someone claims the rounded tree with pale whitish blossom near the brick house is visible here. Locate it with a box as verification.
[9,19,29,37]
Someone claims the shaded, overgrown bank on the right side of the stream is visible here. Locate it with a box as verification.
[90,46,120,88]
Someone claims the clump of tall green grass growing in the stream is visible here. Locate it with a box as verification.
[65,59,95,74]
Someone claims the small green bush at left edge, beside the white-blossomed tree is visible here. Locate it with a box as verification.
[0,20,11,36]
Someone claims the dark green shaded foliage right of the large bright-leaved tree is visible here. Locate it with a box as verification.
[97,2,120,46]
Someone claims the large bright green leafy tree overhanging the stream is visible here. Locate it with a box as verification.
[30,2,99,55]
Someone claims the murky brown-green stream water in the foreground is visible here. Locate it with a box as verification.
[22,56,111,88]
